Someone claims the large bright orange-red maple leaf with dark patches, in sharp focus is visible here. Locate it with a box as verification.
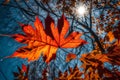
[9,15,86,63]
